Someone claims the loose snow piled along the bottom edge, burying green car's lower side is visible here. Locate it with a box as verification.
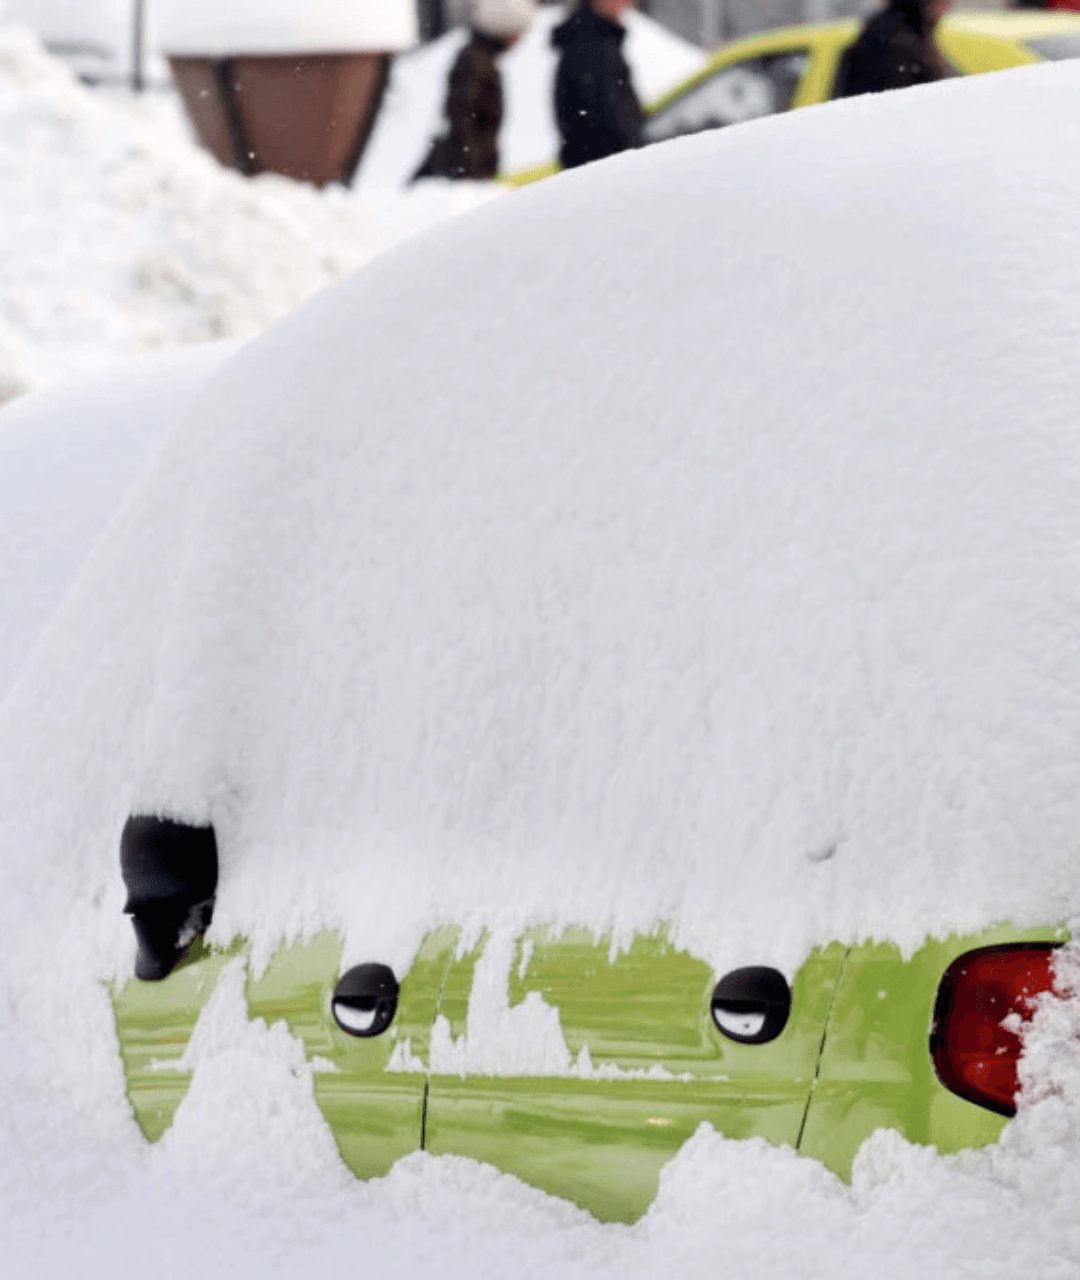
[0,979,1080,1280]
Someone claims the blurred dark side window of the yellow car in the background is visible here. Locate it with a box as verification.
[645,50,809,142]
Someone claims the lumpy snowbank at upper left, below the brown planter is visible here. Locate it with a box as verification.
[0,27,490,401]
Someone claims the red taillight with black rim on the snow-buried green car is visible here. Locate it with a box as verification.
[930,943,1056,1116]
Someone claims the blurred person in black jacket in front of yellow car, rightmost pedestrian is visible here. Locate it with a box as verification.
[833,0,952,97]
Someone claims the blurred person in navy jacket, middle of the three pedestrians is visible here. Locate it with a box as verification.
[552,0,642,169]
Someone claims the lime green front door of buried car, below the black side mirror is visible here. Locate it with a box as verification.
[113,932,457,1178]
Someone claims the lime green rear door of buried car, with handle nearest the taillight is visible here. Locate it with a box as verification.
[426,931,845,1221]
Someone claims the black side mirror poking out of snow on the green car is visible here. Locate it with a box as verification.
[120,817,218,982]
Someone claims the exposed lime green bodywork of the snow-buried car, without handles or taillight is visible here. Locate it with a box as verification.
[113,927,1065,1221]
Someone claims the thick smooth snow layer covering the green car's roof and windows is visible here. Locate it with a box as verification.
[0,57,1080,970]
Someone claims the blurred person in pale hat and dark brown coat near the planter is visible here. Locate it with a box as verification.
[412,0,536,182]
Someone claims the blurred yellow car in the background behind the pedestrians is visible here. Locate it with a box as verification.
[503,10,1080,187]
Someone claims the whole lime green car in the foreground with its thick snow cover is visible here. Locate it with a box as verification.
[0,55,1080,1219]
